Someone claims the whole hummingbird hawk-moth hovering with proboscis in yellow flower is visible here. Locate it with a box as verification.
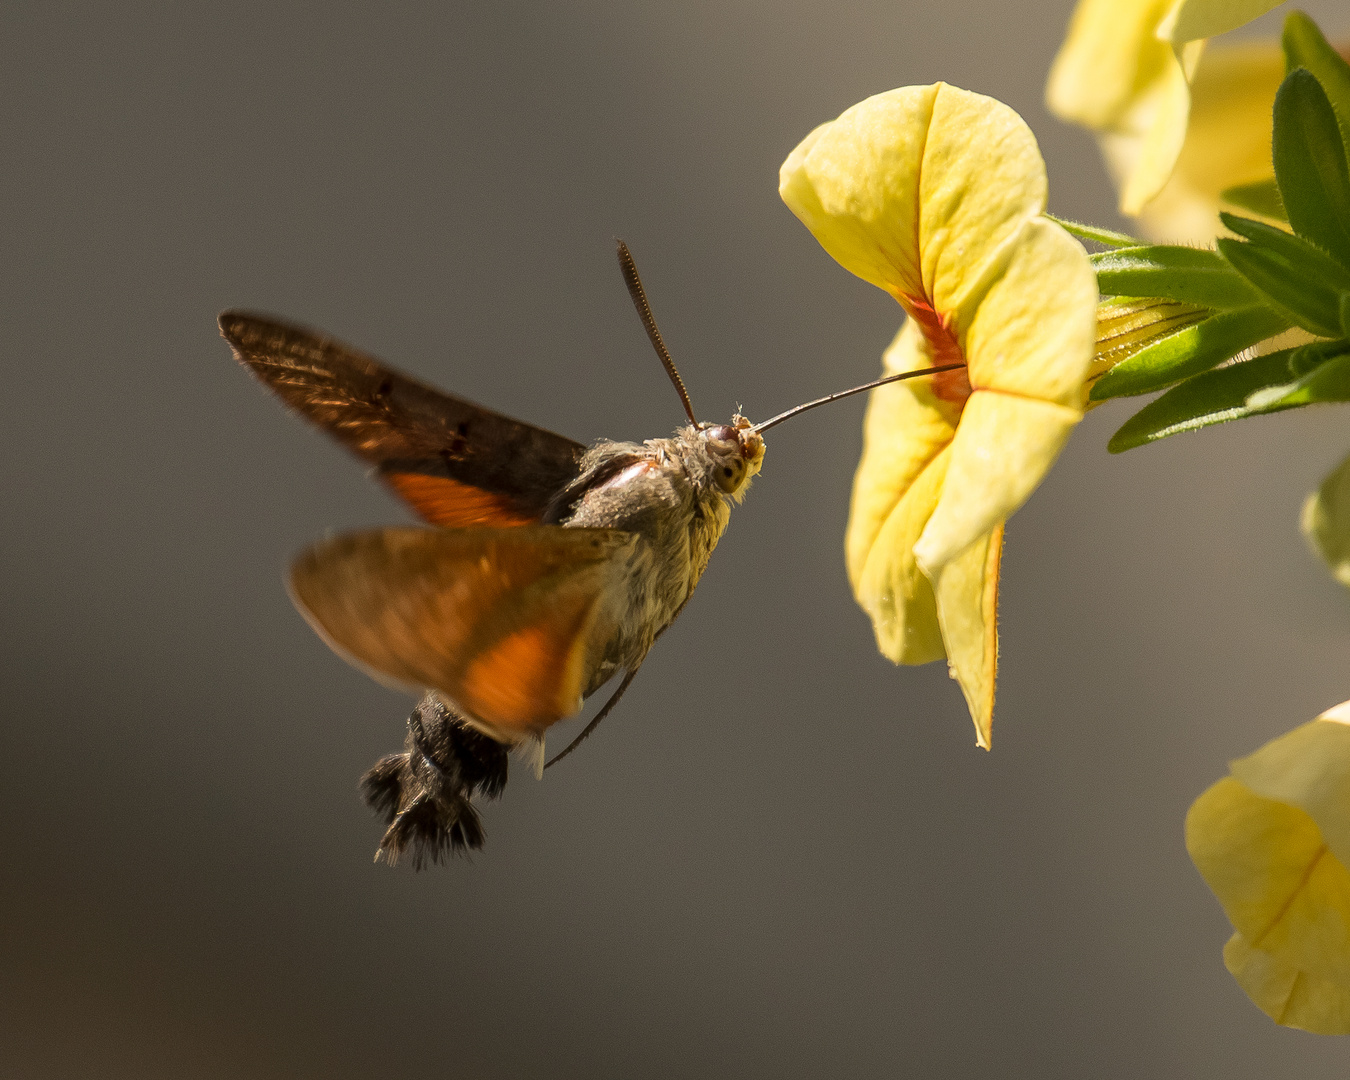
[220,242,952,868]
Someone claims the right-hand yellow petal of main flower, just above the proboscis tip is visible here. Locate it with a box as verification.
[964,219,1098,409]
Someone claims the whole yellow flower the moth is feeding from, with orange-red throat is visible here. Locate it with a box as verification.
[779,82,1098,747]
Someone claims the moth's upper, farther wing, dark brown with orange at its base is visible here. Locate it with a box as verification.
[220,312,586,528]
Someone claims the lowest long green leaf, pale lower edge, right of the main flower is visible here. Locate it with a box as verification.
[1106,348,1296,454]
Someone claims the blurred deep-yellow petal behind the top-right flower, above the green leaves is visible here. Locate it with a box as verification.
[1138,41,1284,244]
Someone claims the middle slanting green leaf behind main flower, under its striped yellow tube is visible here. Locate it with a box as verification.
[1088,304,1289,401]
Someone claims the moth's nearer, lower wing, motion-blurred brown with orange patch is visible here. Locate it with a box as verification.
[290,525,635,740]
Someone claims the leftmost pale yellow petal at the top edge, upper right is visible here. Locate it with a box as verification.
[1045,0,1175,131]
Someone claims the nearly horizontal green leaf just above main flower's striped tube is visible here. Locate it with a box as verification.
[1091,244,1261,311]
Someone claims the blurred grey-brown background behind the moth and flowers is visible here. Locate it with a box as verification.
[0,0,1350,1080]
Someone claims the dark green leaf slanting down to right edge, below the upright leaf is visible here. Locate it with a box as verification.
[1218,213,1350,338]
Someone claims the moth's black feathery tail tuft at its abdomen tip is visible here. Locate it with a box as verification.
[360,694,510,869]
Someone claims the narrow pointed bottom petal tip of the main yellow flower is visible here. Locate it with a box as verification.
[934,522,1003,749]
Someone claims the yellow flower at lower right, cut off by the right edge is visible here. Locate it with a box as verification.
[1185,702,1350,1035]
